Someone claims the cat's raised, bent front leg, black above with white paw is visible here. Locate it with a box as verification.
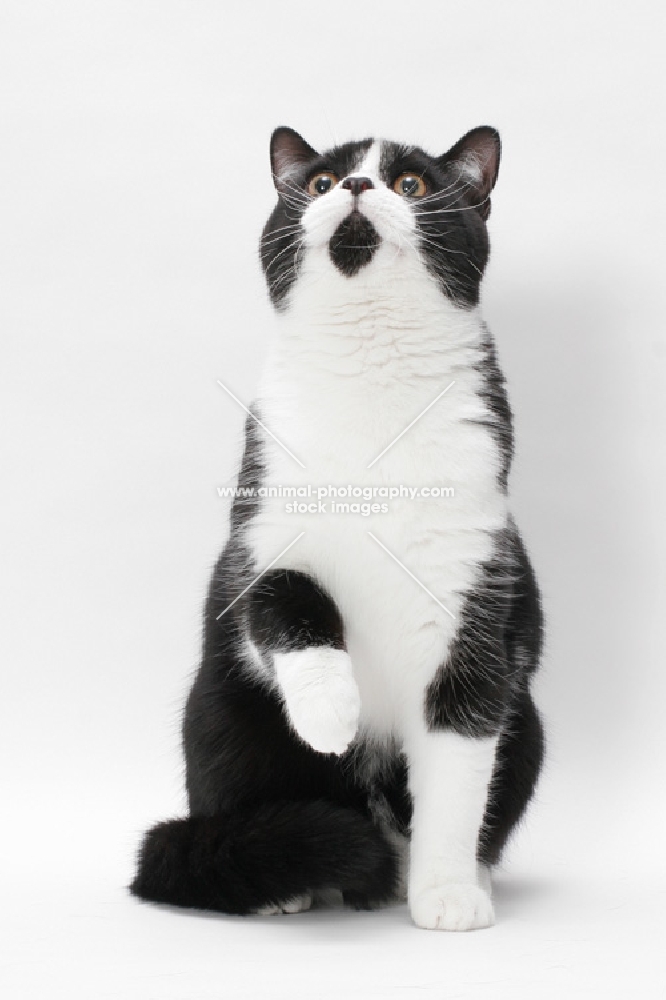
[249,569,361,755]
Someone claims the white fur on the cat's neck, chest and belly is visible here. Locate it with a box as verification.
[247,248,506,735]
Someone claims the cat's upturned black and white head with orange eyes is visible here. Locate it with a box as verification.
[260,126,500,309]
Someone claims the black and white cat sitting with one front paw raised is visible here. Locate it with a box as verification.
[132,127,543,930]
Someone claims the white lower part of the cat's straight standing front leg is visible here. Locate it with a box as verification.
[408,729,498,931]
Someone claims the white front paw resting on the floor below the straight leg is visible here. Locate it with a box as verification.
[409,883,495,931]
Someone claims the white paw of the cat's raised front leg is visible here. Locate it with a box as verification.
[275,646,361,754]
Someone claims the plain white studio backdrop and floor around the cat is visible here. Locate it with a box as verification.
[0,0,666,1000]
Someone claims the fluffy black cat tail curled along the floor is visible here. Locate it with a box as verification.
[130,800,398,915]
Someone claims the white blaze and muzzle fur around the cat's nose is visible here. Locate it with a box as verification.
[302,140,416,254]
